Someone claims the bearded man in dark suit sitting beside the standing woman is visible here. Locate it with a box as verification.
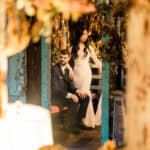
[51,49,89,134]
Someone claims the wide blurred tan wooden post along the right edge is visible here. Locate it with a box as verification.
[125,0,150,150]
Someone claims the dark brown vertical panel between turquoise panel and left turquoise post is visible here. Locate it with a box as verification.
[26,42,41,105]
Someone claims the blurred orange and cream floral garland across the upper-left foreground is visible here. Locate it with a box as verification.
[0,0,95,56]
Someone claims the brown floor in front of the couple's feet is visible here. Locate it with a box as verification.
[53,127,101,150]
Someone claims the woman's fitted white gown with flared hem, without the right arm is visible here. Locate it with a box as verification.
[73,52,101,128]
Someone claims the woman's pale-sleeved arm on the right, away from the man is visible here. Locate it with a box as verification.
[89,45,102,73]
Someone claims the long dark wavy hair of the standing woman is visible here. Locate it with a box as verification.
[69,16,89,60]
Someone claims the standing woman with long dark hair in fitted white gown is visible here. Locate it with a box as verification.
[70,17,102,128]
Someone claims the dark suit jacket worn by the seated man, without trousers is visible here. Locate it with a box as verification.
[51,64,76,106]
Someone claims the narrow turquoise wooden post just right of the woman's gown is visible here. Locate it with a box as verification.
[101,61,109,144]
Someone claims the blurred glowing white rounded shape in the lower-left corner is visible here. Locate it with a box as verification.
[0,104,53,150]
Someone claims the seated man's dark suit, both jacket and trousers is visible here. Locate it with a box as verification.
[51,64,89,127]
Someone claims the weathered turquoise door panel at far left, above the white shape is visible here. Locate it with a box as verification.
[7,52,26,102]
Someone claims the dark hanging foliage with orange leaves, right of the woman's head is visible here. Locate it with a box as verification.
[91,0,128,64]
